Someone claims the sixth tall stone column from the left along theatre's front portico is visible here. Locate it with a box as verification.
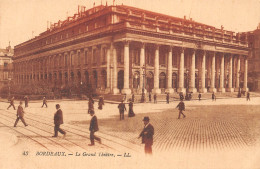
[189,49,197,93]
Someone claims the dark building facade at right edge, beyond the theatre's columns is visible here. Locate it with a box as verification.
[248,23,260,91]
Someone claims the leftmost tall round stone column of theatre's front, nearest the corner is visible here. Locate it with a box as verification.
[122,41,131,94]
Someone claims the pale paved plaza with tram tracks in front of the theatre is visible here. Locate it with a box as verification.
[0,97,260,169]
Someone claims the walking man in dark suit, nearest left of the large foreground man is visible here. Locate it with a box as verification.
[89,110,101,146]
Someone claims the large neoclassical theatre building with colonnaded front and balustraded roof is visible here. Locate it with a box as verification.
[14,5,250,94]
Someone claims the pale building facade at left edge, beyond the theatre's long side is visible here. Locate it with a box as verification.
[0,44,14,89]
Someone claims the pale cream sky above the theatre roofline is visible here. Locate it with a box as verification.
[0,0,260,48]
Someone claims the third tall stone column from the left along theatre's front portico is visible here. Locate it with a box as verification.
[153,45,161,94]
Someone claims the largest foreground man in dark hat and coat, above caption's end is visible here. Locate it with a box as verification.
[138,117,154,155]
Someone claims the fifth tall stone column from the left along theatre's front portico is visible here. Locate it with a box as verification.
[177,48,186,93]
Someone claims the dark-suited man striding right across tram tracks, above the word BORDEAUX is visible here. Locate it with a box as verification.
[52,104,66,138]
